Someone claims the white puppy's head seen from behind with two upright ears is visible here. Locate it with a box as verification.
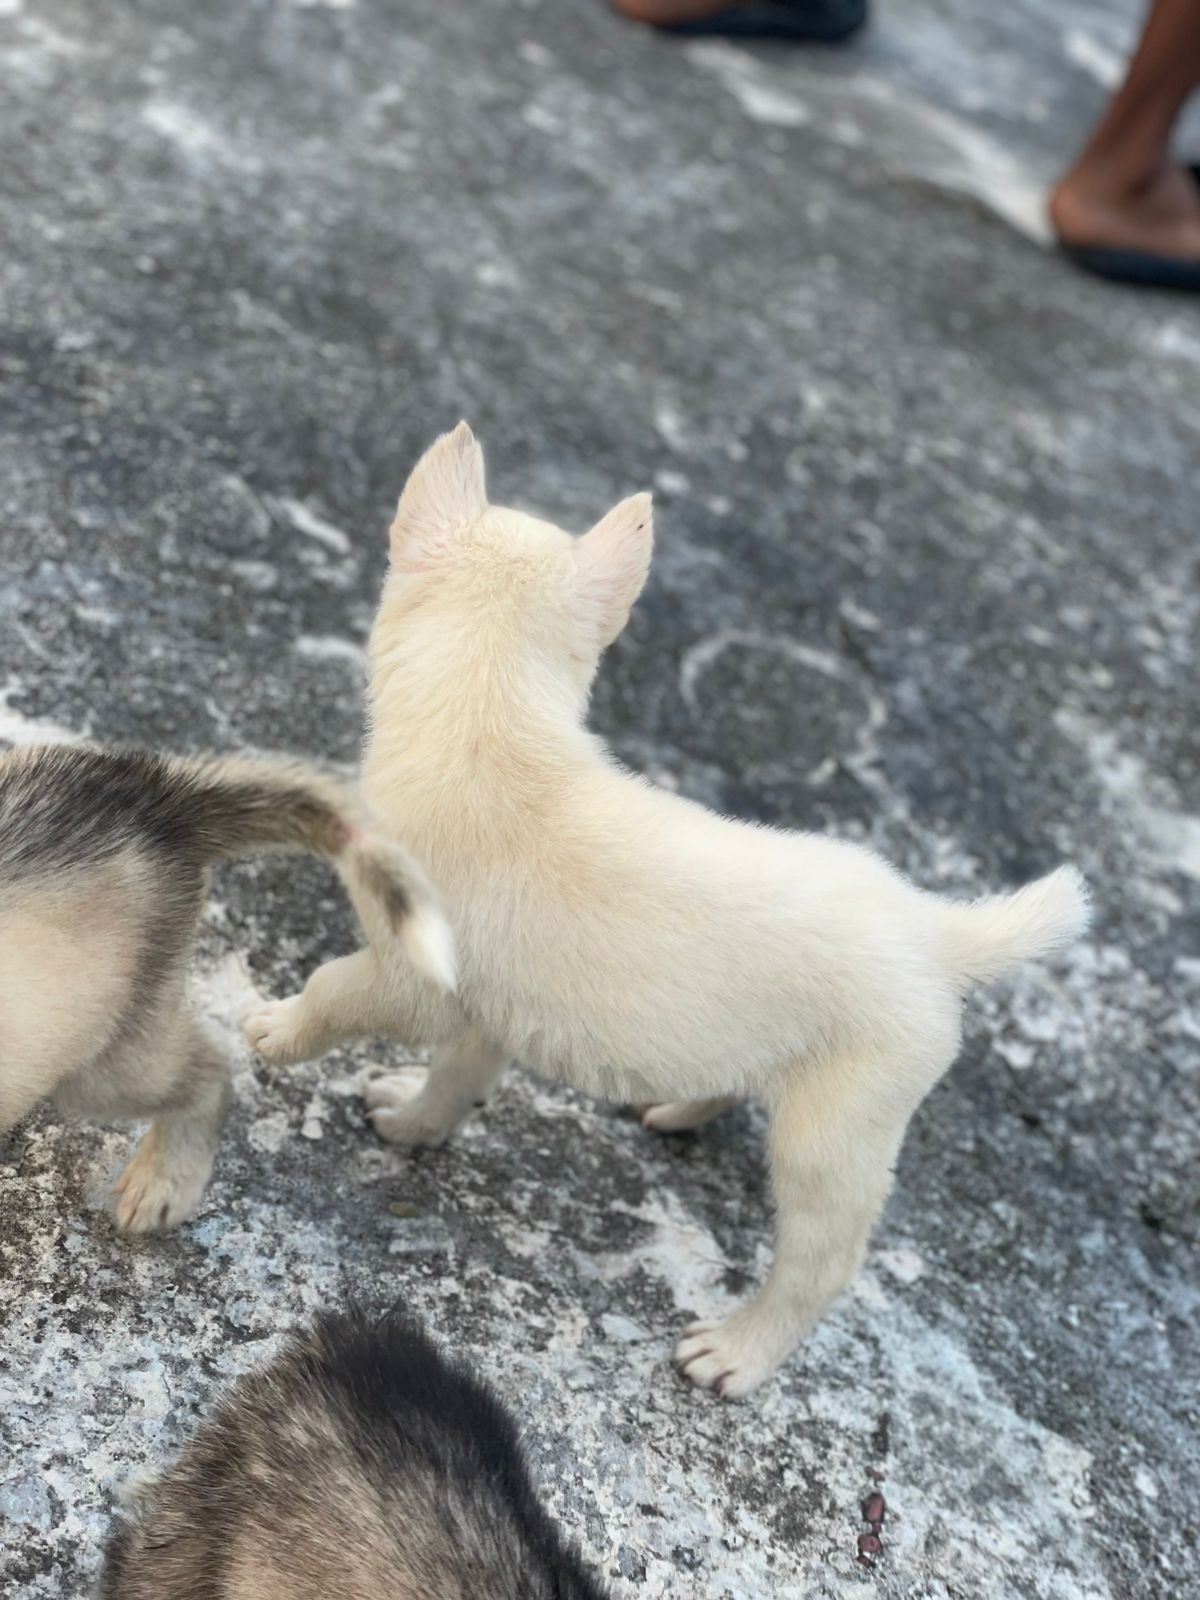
[376,422,653,691]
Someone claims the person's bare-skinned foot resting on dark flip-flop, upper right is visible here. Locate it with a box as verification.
[1050,160,1200,261]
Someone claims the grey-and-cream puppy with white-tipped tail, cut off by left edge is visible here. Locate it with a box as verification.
[0,746,454,1234]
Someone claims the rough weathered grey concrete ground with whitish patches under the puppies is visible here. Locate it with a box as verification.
[0,0,1200,1600]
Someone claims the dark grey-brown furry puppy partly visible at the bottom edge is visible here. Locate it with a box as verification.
[98,1314,605,1600]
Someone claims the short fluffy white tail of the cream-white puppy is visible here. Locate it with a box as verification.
[941,867,1091,986]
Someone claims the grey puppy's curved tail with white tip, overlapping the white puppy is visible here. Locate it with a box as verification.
[178,755,458,989]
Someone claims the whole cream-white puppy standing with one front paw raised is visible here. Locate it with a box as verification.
[246,426,1088,1397]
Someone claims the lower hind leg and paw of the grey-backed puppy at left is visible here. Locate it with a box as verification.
[114,1014,230,1234]
